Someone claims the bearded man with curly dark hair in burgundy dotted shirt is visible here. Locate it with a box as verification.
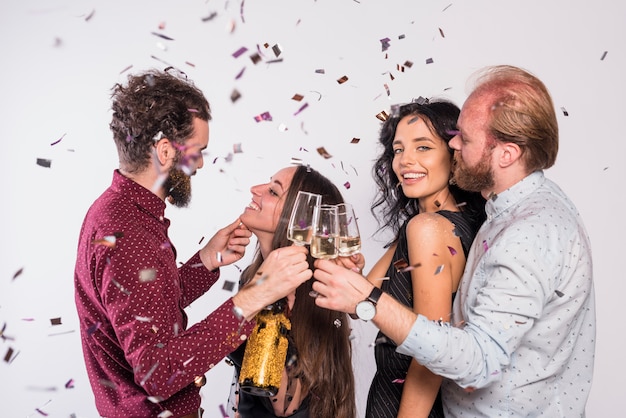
[74,70,312,418]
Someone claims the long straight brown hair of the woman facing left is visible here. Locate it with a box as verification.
[241,166,356,418]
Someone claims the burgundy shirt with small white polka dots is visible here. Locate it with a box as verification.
[74,170,253,418]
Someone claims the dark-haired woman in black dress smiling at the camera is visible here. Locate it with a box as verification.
[366,99,485,418]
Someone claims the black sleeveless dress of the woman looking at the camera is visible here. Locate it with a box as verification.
[365,211,480,418]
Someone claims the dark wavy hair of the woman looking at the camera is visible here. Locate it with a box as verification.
[371,99,484,246]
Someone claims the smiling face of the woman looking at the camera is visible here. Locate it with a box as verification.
[392,115,452,208]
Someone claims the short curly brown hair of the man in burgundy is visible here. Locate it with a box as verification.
[109,67,211,173]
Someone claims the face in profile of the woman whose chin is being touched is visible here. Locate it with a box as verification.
[241,167,296,242]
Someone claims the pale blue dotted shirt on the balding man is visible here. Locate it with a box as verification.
[397,171,596,418]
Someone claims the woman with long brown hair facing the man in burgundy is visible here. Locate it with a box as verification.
[230,166,356,418]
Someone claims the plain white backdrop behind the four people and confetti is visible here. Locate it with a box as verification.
[0,0,626,418]
